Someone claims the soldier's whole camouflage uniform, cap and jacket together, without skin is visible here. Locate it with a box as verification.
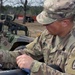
[0,0,75,75]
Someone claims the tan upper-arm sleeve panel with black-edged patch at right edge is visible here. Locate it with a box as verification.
[65,48,75,75]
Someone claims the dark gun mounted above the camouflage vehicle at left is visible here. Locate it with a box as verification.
[4,15,29,36]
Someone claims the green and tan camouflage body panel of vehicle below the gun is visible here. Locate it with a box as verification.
[0,32,20,51]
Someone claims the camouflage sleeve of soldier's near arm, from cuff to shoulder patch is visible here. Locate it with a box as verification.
[31,47,75,75]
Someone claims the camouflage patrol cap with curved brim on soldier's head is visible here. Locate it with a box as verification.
[36,0,75,24]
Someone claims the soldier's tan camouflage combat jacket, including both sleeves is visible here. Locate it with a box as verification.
[0,26,75,75]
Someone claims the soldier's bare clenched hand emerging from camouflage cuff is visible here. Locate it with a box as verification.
[16,54,34,69]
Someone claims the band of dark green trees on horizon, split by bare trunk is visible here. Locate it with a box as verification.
[2,5,43,15]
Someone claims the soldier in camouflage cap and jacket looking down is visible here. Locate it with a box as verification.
[0,0,75,75]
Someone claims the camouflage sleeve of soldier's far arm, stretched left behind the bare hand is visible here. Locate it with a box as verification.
[0,31,43,68]
